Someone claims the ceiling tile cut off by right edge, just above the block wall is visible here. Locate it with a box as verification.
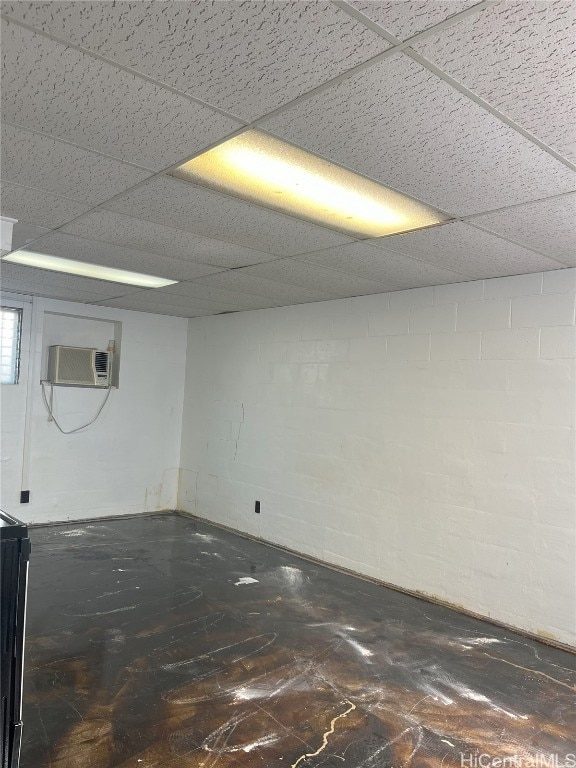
[470,195,576,258]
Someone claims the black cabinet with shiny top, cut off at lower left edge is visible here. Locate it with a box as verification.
[0,512,30,768]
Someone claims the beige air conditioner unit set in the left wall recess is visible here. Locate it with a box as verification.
[48,345,112,387]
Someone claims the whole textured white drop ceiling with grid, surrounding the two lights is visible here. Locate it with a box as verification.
[0,0,576,317]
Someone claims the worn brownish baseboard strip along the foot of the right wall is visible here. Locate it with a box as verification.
[174,509,576,655]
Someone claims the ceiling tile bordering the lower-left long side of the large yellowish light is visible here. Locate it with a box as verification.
[106,176,351,256]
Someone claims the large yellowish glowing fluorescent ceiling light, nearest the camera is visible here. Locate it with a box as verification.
[170,130,447,238]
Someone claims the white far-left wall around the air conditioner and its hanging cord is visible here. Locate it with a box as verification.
[0,296,187,523]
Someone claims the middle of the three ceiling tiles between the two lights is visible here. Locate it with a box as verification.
[63,209,277,268]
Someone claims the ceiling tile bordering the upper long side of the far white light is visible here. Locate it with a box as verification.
[24,232,221,280]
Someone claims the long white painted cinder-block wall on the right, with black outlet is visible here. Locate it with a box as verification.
[179,270,576,645]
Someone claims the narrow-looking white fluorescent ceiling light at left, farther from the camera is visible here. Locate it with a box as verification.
[2,250,178,288]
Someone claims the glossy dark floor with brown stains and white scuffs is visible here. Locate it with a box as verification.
[22,515,576,768]
